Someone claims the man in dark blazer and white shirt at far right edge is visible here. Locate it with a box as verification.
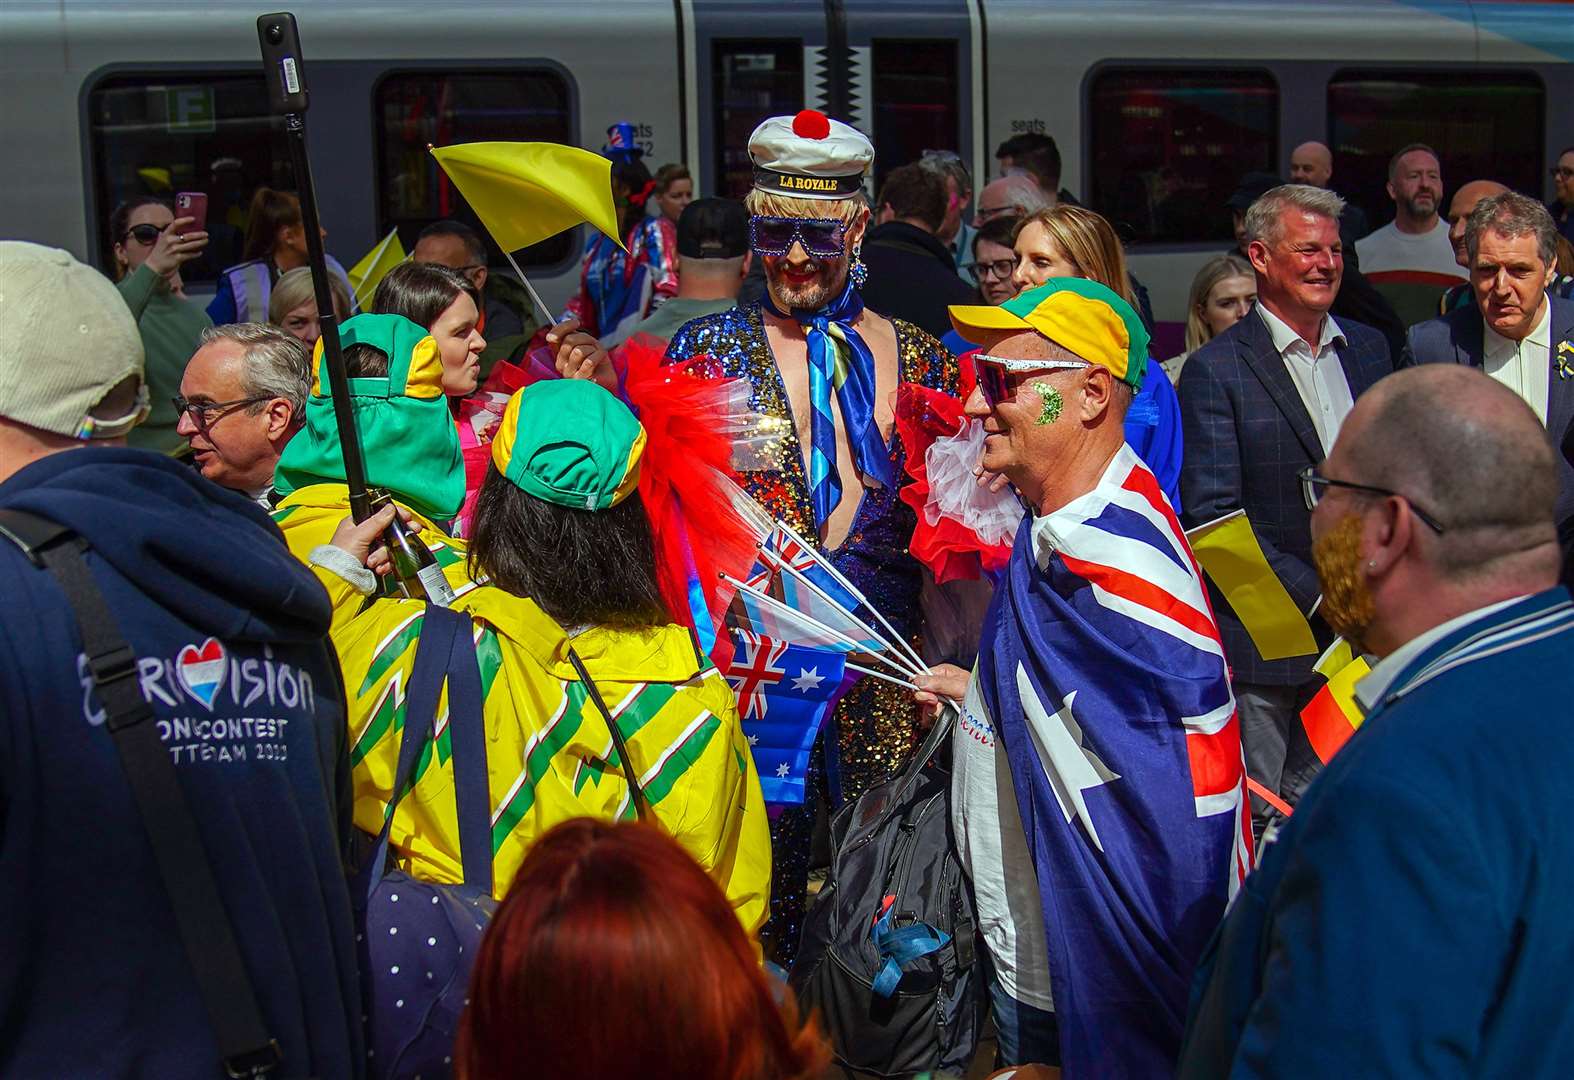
[1399,192,1574,576]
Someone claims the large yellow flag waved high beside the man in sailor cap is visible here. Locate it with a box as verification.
[431,143,623,252]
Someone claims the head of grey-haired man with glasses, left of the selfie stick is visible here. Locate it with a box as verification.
[175,323,312,510]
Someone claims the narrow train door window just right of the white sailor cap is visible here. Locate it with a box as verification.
[869,39,962,190]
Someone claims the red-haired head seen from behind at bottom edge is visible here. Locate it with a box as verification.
[455,817,828,1080]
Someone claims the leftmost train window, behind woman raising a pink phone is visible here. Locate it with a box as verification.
[88,74,293,283]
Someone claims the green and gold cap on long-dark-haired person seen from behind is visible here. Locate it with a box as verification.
[493,379,645,510]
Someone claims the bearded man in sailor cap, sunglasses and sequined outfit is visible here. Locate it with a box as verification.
[667,110,957,965]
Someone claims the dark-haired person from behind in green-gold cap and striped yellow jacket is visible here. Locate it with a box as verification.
[305,382,770,935]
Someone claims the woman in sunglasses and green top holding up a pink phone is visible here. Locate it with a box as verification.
[109,195,211,453]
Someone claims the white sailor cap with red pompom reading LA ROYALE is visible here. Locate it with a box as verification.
[749,109,875,198]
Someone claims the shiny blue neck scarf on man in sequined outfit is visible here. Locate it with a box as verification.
[765,282,896,532]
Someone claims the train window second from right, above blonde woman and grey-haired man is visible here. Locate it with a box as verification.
[1088,68,1278,244]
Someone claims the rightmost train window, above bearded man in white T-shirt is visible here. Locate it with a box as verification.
[1328,68,1546,227]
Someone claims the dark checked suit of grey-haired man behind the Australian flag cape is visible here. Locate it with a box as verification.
[1177,313,1393,686]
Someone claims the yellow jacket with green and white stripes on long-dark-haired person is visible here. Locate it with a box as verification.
[283,485,771,934]
